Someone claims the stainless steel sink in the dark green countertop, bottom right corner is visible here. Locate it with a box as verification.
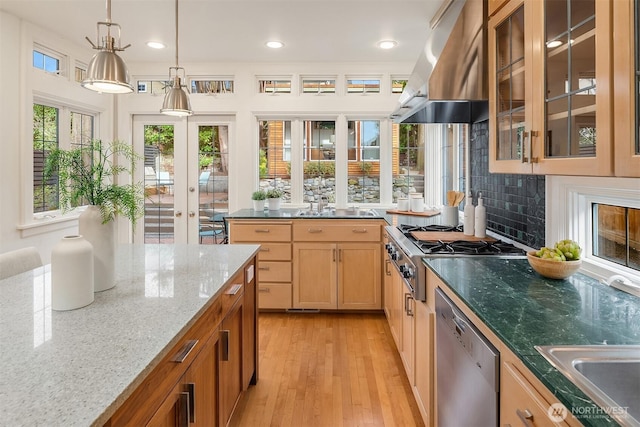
[536,345,640,426]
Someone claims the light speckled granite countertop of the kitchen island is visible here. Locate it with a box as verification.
[0,245,259,427]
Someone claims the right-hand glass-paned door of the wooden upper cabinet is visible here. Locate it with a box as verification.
[530,0,612,175]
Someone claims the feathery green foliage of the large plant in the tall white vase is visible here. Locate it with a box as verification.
[44,140,144,226]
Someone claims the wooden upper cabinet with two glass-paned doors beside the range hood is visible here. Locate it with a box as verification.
[488,0,613,175]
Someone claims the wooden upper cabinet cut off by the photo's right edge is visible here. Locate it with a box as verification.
[613,0,640,177]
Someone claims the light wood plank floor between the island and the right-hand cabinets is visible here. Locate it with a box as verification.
[230,313,423,427]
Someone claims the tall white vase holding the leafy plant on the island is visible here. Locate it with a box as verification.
[78,205,116,292]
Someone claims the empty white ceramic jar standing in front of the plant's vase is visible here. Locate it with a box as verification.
[51,236,94,311]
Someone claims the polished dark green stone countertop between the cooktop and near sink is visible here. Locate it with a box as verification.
[424,257,640,426]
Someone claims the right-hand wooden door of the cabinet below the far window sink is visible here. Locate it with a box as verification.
[338,243,382,310]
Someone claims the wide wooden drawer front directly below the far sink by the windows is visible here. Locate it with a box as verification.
[293,220,381,242]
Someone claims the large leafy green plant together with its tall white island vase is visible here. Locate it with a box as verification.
[44,140,144,291]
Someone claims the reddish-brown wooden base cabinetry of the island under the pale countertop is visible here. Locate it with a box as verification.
[105,259,258,427]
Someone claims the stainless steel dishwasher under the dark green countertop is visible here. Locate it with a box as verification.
[435,289,500,427]
